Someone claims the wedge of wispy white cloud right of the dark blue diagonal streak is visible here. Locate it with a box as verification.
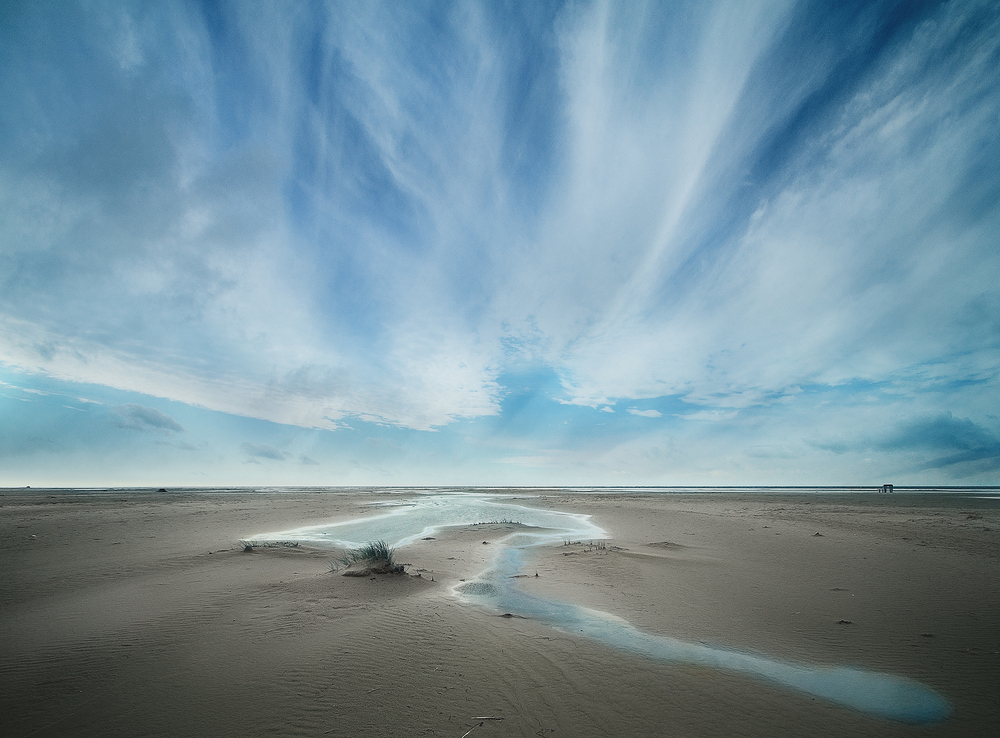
[548,0,1000,408]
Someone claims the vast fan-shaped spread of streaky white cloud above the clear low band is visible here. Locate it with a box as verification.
[0,3,1000,488]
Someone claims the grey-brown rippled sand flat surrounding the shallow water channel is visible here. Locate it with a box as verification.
[0,490,1000,738]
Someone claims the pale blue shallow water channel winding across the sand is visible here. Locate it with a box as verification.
[254,492,951,723]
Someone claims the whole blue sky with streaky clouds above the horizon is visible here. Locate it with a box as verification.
[0,0,1000,487]
